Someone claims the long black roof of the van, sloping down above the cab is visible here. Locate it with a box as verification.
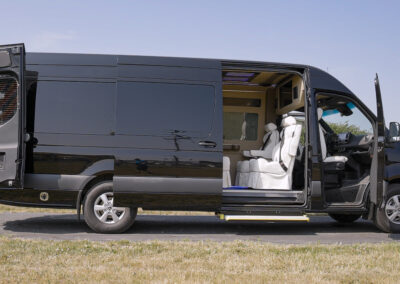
[26,53,353,94]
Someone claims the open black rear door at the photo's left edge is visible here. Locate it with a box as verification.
[0,44,25,188]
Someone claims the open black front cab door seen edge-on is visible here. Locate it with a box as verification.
[370,74,386,206]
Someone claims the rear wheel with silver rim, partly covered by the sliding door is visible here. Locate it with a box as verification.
[83,181,137,234]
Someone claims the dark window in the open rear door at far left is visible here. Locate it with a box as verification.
[0,78,18,125]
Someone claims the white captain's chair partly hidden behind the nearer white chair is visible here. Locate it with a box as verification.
[235,122,279,187]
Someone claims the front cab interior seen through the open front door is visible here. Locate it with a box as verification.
[317,94,374,204]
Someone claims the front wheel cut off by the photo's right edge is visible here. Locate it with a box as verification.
[374,184,400,233]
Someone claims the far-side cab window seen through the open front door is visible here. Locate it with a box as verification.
[320,99,373,135]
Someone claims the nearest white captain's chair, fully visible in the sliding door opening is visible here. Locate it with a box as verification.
[249,116,301,190]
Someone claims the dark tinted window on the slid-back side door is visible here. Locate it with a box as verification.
[116,82,215,136]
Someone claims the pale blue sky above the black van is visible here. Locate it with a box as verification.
[0,0,400,123]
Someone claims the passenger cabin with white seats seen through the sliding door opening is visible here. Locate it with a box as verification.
[222,70,305,203]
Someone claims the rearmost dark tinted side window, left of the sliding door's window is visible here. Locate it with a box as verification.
[35,81,115,134]
